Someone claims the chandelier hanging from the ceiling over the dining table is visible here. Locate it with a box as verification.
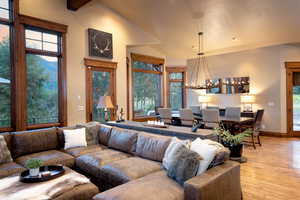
[186,32,215,90]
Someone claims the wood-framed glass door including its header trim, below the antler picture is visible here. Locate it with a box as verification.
[85,58,117,122]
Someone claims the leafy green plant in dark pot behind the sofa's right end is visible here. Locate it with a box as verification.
[215,127,253,158]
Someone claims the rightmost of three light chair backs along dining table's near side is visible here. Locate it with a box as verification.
[202,109,220,129]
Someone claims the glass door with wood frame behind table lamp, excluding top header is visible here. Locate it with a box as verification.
[86,67,116,122]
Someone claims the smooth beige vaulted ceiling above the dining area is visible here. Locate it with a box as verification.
[98,0,300,58]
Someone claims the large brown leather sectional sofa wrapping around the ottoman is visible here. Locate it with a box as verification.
[0,123,242,200]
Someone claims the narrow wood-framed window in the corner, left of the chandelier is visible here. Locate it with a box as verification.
[167,67,186,111]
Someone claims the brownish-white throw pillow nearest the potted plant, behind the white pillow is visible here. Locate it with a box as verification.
[203,139,230,169]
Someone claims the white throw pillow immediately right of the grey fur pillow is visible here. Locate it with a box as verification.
[191,138,217,176]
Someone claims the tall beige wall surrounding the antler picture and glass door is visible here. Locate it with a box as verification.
[20,0,158,125]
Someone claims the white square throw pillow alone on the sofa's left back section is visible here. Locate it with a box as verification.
[64,128,87,149]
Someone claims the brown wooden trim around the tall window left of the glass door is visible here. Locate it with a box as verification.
[15,15,68,130]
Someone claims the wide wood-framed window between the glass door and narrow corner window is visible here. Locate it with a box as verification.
[132,54,164,119]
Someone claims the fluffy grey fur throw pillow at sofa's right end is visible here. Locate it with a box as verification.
[167,145,202,185]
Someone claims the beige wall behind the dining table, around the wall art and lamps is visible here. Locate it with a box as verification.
[188,45,300,133]
